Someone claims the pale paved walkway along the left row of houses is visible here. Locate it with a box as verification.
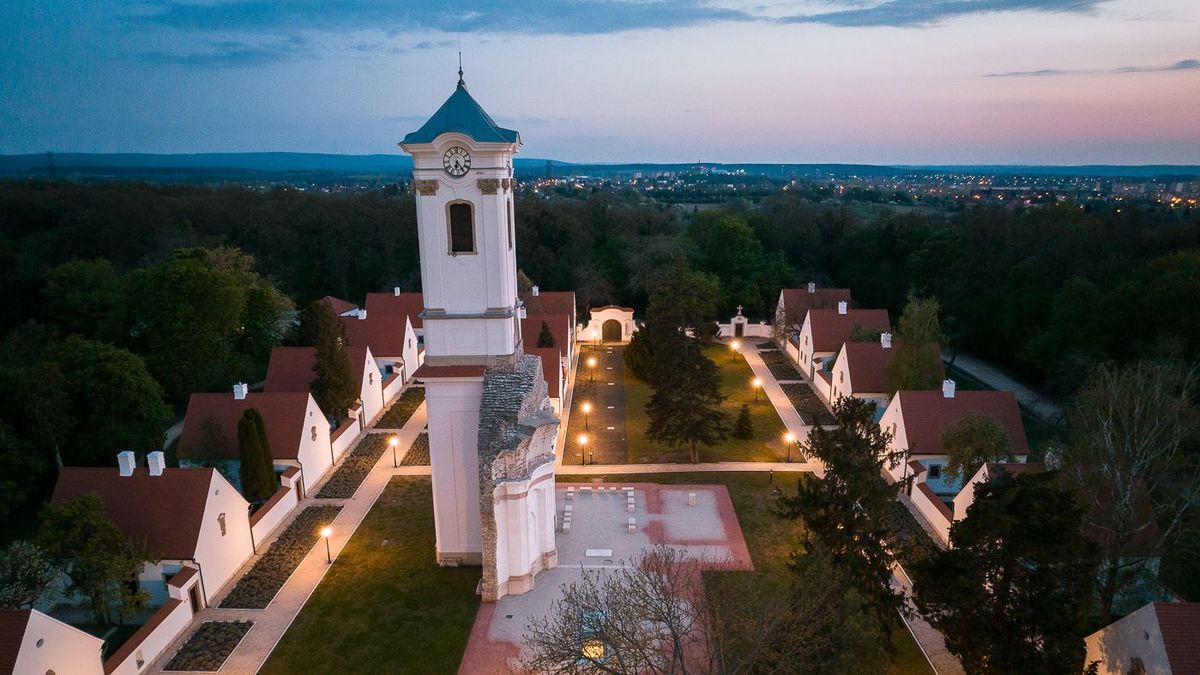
[149,402,430,673]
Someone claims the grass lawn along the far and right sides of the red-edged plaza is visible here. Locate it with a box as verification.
[558,472,934,675]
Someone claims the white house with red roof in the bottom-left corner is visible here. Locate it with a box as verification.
[0,609,104,675]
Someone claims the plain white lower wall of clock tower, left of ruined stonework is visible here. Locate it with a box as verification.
[425,377,484,563]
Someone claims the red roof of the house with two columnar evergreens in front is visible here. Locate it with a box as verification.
[179,392,314,460]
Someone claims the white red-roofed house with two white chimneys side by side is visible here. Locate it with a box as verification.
[52,450,254,607]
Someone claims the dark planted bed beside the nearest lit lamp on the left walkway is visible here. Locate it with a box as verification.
[221,504,342,609]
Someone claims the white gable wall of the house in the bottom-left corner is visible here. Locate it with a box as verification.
[12,609,104,675]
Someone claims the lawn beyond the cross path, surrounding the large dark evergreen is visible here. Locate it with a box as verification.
[625,345,787,464]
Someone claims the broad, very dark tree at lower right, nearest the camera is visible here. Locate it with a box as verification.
[911,473,1097,675]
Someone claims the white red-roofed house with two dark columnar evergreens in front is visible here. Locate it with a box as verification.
[179,384,336,498]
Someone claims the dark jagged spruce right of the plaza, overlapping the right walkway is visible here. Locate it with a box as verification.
[779,396,902,635]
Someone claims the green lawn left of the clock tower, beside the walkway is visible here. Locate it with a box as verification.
[260,477,480,674]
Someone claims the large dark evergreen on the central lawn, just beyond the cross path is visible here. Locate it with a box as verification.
[646,329,728,464]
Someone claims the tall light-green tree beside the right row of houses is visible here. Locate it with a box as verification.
[887,297,942,393]
